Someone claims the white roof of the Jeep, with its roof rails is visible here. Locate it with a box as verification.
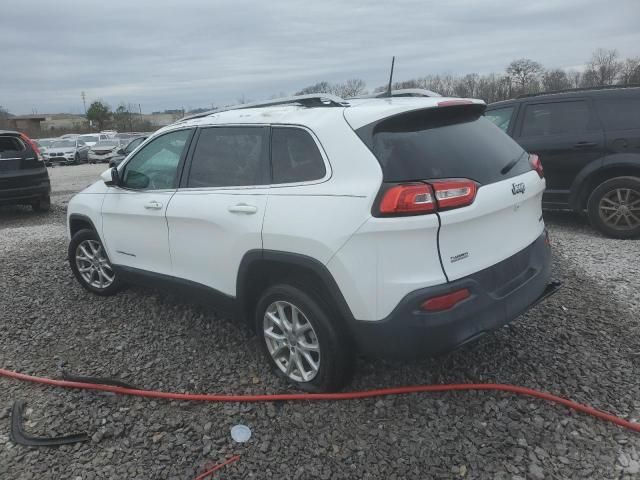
[164,97,485,132]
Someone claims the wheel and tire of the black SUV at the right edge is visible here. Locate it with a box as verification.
[587,177,640,238]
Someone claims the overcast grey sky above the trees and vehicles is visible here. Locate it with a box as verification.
[0,0,640,114]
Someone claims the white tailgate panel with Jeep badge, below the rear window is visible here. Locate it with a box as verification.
[438,171,545,281]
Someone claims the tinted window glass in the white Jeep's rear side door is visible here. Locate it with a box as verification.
[187,127,269,188]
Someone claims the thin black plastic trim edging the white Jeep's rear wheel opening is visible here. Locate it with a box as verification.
[236,249,355,324]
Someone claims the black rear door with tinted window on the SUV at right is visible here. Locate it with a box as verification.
[515,98,605,205]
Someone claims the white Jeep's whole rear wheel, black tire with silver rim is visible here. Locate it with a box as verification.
[255,284,355,392]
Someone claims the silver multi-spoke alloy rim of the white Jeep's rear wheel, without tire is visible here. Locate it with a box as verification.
[263,301,320,382]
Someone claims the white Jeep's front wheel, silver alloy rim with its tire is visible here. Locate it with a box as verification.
[68,229,123,296]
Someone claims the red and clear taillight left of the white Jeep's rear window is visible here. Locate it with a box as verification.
[378,178,478,216]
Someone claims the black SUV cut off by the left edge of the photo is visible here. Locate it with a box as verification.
[0,130,51,211]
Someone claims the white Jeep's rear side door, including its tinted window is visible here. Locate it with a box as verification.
[167,126,270,296]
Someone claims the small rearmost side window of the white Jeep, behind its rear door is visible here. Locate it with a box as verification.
[271,127,327,184]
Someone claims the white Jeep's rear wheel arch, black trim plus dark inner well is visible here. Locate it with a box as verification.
[236,250,354,330]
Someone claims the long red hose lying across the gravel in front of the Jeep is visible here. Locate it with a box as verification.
[0,368,640,432]
